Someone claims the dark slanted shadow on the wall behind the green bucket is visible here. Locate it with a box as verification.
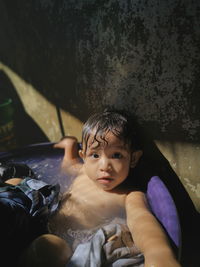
[0,71,48,146]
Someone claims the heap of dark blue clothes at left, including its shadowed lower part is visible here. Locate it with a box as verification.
[0,178,60,266]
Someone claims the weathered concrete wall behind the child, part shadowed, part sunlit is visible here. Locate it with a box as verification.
[0,0,200,264]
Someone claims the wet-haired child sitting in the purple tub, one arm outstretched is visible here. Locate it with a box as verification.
[20,111,180,267]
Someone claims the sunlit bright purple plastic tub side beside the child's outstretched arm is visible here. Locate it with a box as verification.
[147,176,181,250]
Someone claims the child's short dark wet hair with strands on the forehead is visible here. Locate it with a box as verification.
[82,110,140,154]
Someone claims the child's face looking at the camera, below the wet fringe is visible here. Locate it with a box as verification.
[81,132,138,190]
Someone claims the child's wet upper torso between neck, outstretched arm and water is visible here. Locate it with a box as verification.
[59,177,125,228]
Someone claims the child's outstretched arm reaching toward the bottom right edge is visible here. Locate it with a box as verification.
[126,192,180,267]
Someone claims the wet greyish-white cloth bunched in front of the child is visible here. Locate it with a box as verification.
[66,224,144,267]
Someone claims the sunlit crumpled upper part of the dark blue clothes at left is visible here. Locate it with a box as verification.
[0,178,60,217]
